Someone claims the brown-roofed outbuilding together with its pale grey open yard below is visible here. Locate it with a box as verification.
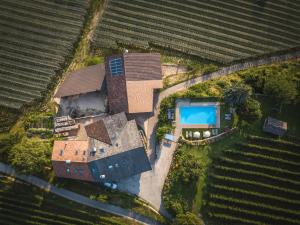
[54,64,106,117]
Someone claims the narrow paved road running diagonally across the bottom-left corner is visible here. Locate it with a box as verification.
[0,163,159,225]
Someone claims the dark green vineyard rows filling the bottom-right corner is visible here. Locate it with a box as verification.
[204,136,300,225]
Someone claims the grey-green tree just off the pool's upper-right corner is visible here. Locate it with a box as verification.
[224,82,252,106]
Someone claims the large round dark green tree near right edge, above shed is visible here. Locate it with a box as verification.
[264,72,298,111]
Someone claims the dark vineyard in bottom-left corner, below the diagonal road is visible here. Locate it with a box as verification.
[0,177,135,225]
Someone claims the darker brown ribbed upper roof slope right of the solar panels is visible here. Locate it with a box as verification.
[123,53,162,81]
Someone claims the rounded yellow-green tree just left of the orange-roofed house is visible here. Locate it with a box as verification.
[8,138,51,174]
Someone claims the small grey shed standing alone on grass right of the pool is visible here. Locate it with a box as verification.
[263,116,287,136]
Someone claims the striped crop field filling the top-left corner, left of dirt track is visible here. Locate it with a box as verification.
[0,0,89,109]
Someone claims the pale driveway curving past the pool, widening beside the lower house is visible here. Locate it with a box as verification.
[119,51,300,217]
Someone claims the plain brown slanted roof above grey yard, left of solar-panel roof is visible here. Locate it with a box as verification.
[55,64,105,98]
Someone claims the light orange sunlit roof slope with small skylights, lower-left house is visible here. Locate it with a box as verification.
[52,140,89,162]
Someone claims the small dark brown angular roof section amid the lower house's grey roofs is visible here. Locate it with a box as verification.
[85,120,111,145]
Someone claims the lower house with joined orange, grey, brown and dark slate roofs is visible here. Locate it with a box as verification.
[52,112,151,182]
